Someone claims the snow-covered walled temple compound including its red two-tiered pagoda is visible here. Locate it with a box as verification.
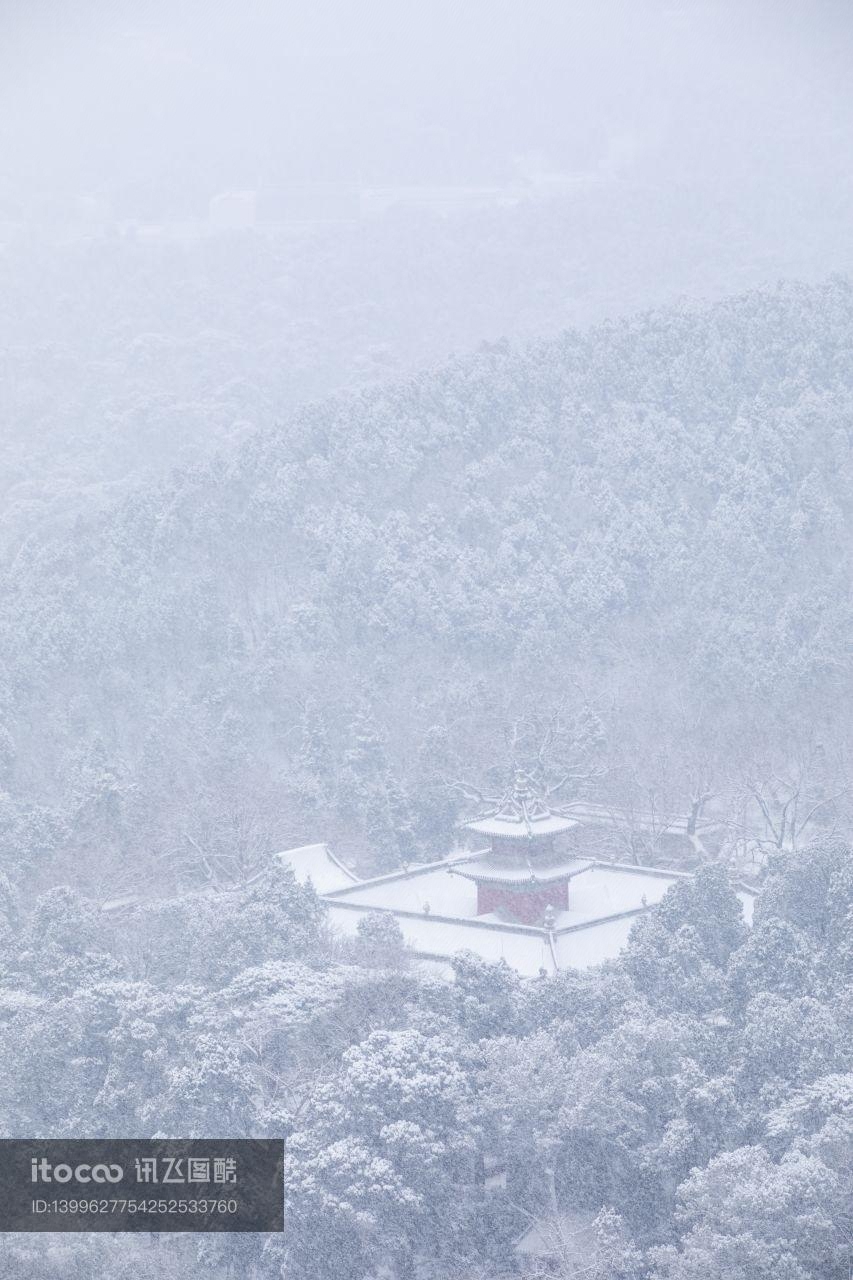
[278,773,754,977]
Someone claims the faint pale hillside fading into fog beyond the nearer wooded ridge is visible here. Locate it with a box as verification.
[6,166,853,556]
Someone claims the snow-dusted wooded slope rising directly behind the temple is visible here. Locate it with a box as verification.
[0,279,853,896]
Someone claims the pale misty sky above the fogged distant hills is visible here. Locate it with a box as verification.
[0,0,853,207]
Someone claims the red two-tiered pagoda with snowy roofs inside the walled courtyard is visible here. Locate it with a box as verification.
[453,771,593,928]
